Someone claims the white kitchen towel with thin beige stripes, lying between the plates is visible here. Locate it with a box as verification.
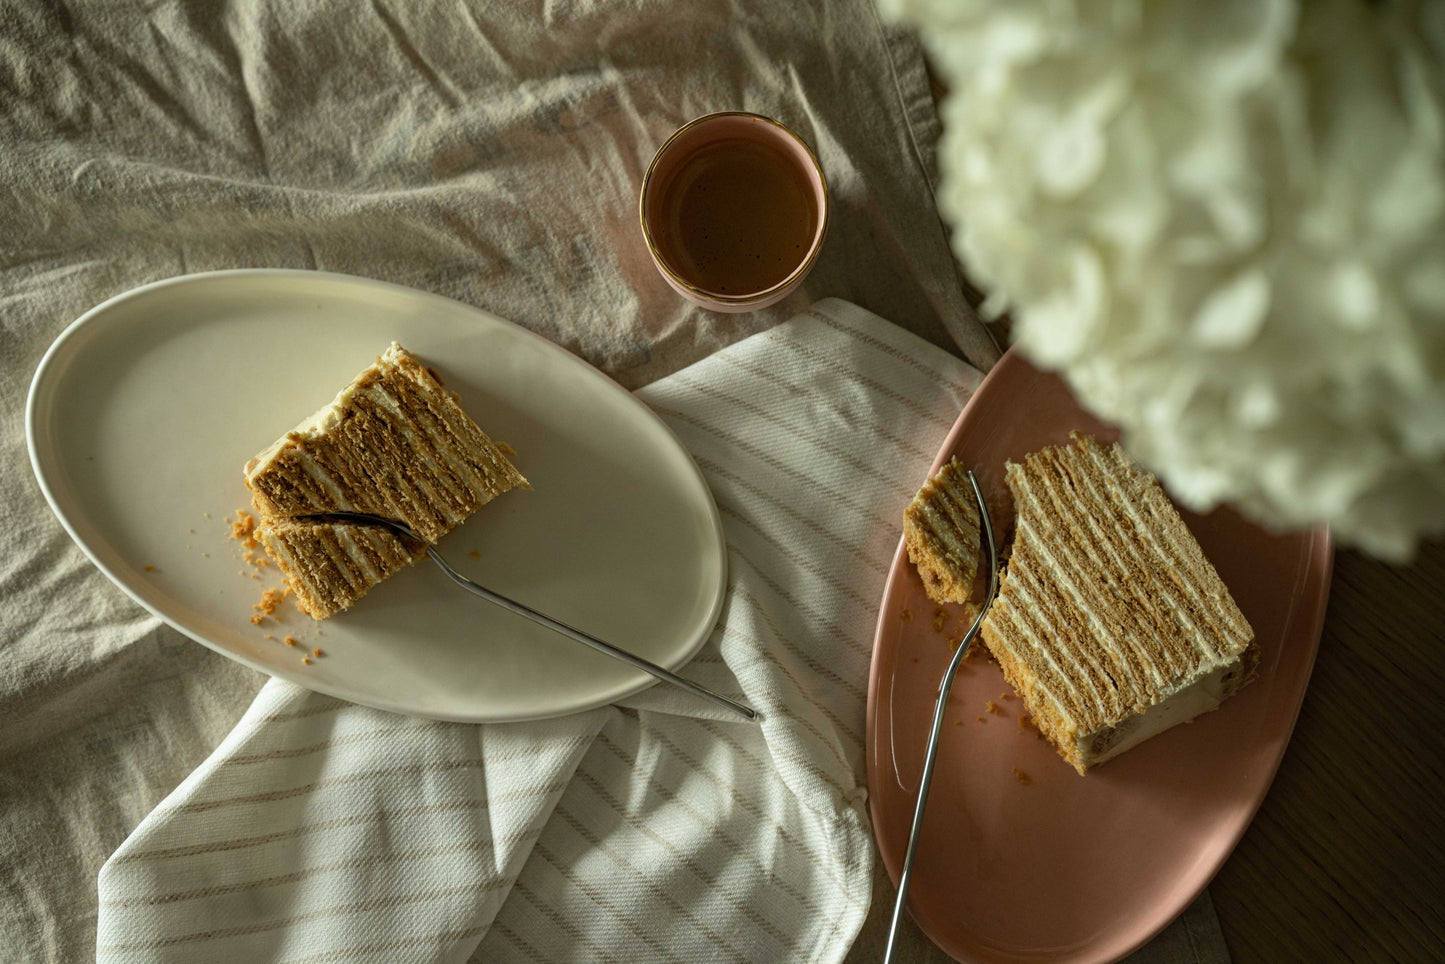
[97,301,981,964]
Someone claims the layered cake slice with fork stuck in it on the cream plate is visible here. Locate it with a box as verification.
[246,343,530,619]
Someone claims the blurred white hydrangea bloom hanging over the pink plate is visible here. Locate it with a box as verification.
[880,0,1445,561]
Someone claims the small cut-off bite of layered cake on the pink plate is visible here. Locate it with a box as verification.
[903,458,978,603]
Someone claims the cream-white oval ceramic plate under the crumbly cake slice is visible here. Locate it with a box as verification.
[26,270,727,723]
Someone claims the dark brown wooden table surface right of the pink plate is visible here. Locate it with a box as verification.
[1209,542,1445,964]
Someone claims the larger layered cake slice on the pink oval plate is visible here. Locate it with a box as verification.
[983,432,1259,773]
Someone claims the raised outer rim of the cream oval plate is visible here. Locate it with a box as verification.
[25,267,728,723]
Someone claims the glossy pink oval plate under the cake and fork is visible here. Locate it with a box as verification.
[867,351,1334,961]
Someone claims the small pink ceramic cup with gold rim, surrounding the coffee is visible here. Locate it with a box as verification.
[637,111,828,312]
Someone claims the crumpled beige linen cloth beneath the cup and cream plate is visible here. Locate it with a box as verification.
[0,0,1222,963]
